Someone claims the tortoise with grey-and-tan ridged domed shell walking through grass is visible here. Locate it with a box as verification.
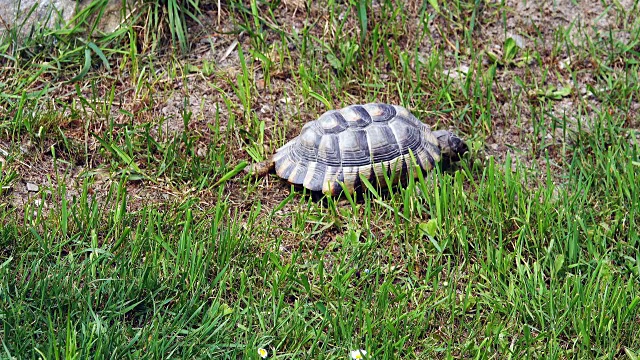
[246,103,468,196]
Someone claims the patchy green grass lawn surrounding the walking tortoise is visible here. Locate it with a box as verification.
[0,0,640,359]
